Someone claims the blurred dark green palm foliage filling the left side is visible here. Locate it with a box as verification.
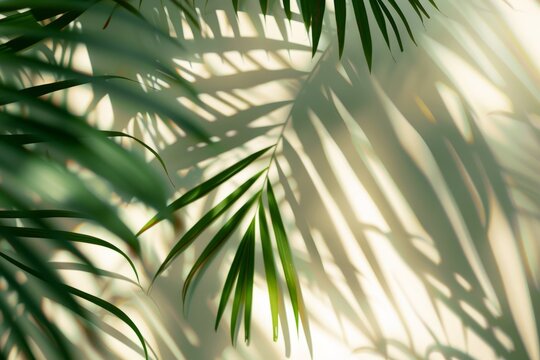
[0,0,200,359]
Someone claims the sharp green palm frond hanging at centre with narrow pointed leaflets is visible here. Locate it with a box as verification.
[139,148,301,343]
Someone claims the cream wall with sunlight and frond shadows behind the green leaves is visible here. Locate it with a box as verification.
[56,0,540,360]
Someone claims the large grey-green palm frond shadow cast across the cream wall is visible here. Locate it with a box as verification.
[71,0,537,357]
